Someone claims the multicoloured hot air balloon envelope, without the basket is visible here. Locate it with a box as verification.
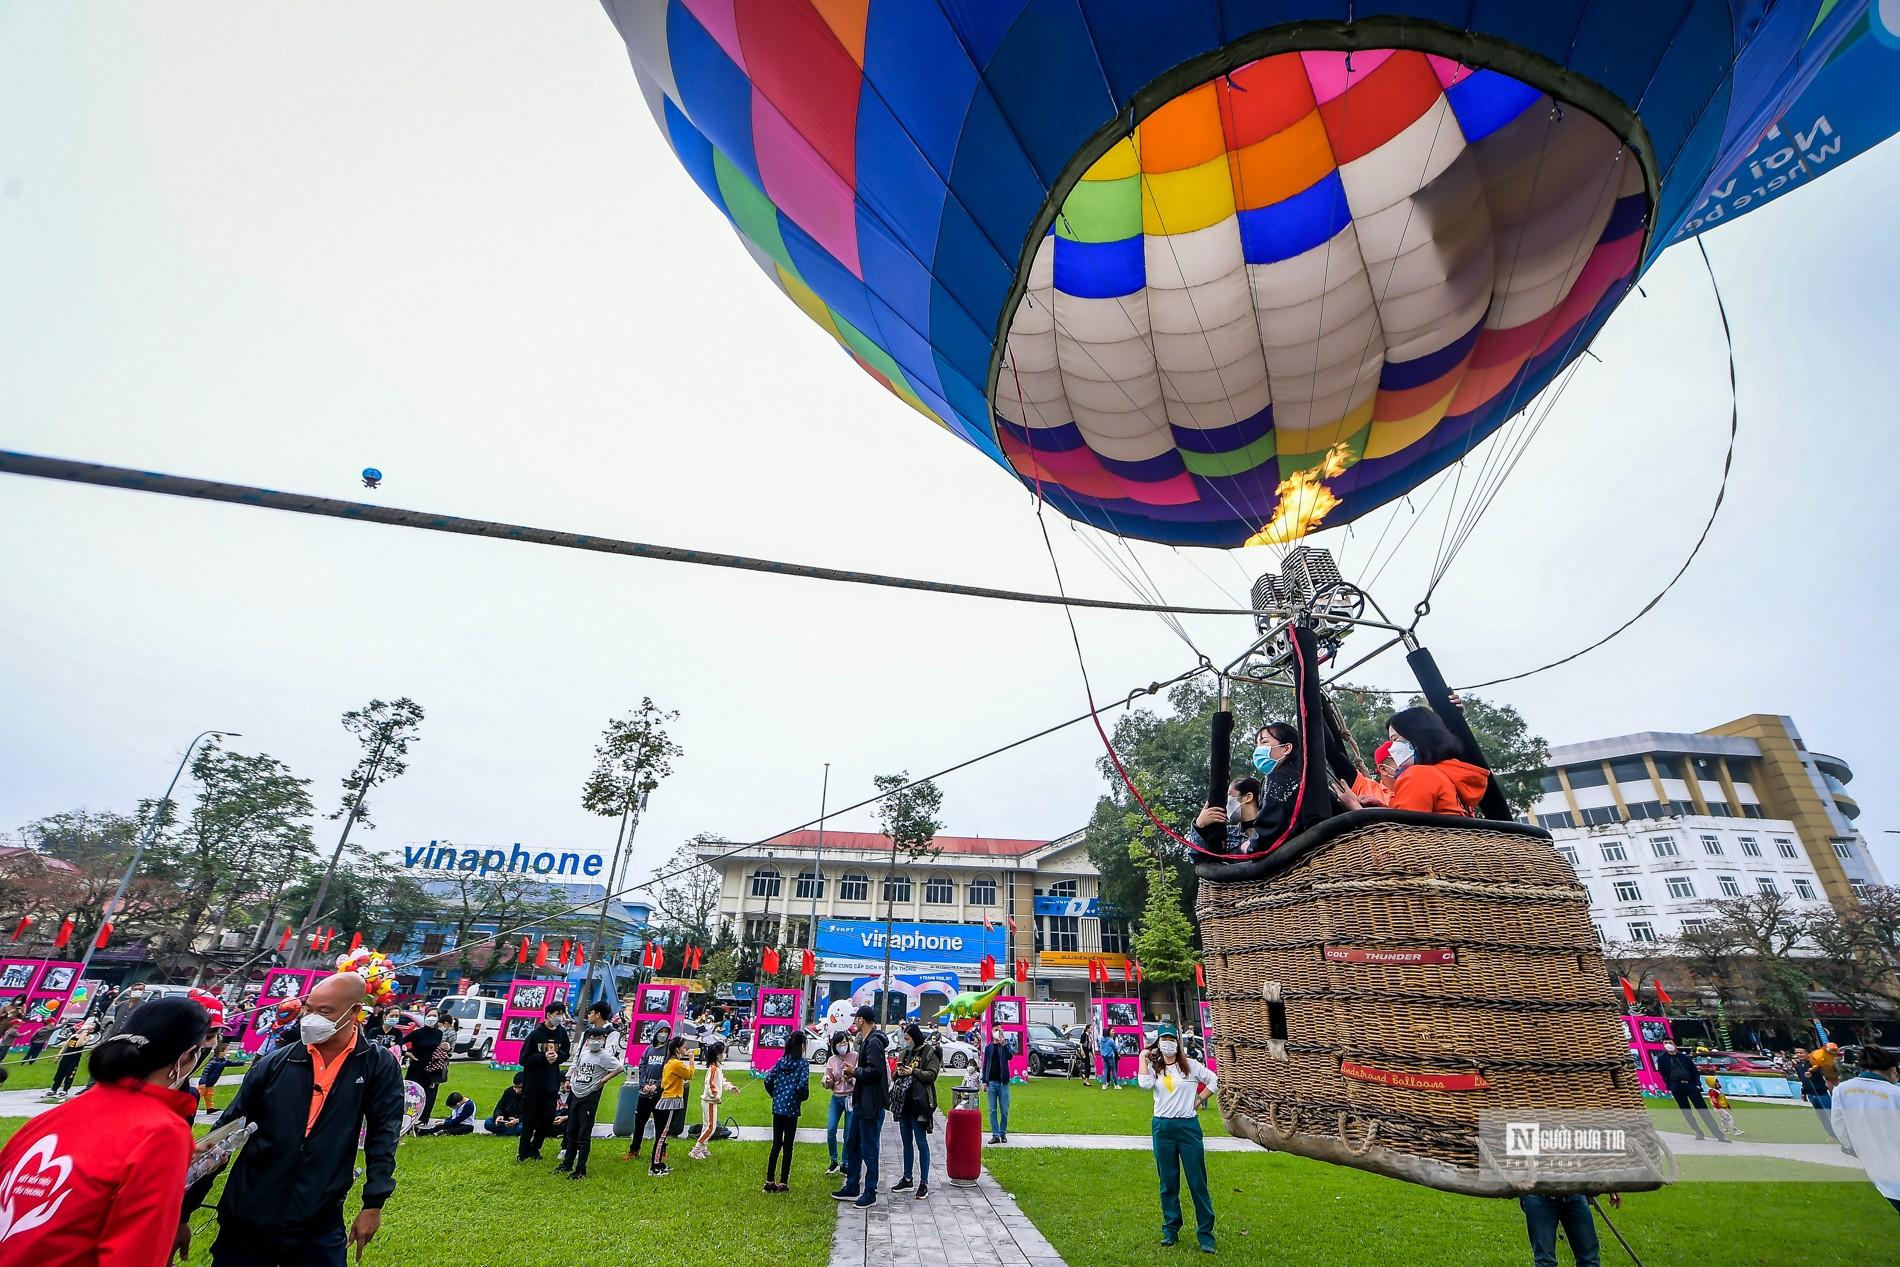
[606,0,1892,545]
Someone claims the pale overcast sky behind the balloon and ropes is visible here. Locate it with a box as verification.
[0,2,1900,892]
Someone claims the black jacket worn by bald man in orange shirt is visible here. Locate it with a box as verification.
[186,1033,403,1240]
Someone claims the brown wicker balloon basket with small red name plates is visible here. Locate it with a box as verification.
[1197,809,1674,1197]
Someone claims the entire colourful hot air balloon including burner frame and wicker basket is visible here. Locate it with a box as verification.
[604,0,1900,1195]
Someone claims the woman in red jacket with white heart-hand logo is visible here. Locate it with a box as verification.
[0,997,211,1267]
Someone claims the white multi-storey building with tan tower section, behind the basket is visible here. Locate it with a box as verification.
[1531,716,1881,944]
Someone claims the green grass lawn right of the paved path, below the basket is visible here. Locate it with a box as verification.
[984,1149,1894,1267]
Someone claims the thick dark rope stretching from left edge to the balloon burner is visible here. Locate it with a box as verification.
[0,450,1252,615]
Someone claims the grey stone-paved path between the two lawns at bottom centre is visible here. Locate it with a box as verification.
[828,1113,1079,1267]
